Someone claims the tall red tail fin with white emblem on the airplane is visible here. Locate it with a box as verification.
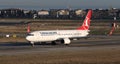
[78,10,92,30]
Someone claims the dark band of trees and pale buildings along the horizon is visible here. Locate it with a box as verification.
[0,8,120,19]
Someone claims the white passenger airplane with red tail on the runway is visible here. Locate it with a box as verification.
[26,9,92,46]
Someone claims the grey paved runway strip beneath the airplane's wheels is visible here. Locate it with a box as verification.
[0,35,120,56]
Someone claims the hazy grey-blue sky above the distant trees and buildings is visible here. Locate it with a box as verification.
[0,0,120,9]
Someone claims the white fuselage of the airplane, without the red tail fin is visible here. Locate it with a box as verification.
[26,30,89,42]
